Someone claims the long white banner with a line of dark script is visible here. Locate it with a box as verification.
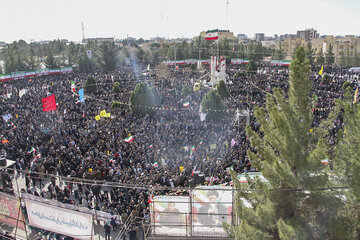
[25,199,93,239]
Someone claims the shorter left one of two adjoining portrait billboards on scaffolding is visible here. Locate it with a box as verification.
[150,196,190,236]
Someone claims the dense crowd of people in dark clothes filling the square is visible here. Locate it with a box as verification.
[0,61,358,239]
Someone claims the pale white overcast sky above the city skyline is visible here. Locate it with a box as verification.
[0,0,360,42]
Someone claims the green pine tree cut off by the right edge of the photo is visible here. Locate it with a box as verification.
[334,94,360,239]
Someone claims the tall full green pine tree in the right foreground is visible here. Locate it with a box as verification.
[226,47,341,240]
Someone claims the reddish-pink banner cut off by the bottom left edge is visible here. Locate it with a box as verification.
[0,193,25,230]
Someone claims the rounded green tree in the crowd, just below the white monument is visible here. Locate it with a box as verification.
[201,90,225,119]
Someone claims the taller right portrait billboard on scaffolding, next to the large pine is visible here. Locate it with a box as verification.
[192,186,233,237]
